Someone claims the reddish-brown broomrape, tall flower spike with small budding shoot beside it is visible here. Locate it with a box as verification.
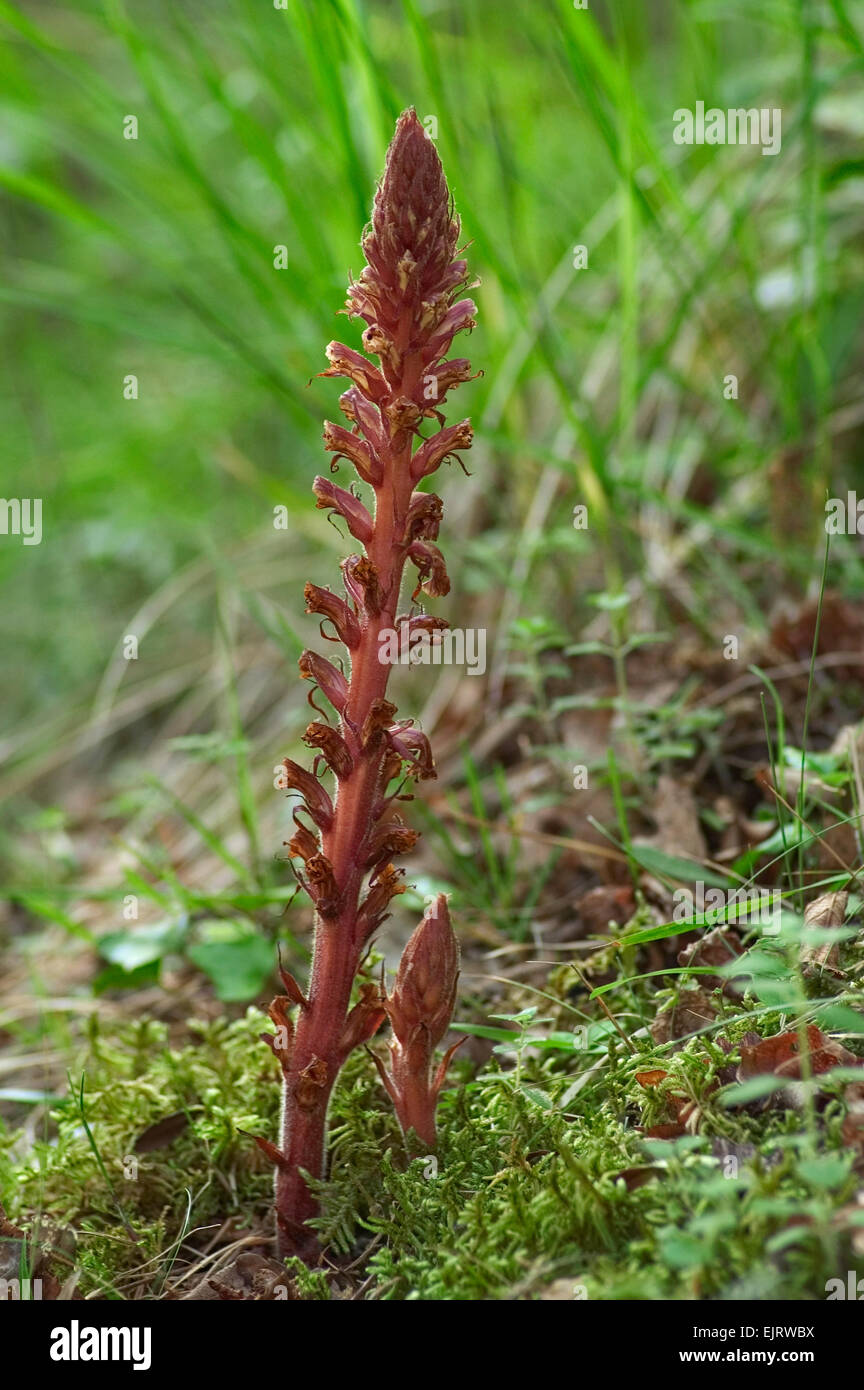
[258,110,475,1261]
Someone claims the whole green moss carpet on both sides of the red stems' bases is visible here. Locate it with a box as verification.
[0,1011,861,1301]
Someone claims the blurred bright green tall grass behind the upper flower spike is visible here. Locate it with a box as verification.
[0,0,864,900]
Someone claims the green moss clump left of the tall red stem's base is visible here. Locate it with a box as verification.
[0,1009,278,1297]
